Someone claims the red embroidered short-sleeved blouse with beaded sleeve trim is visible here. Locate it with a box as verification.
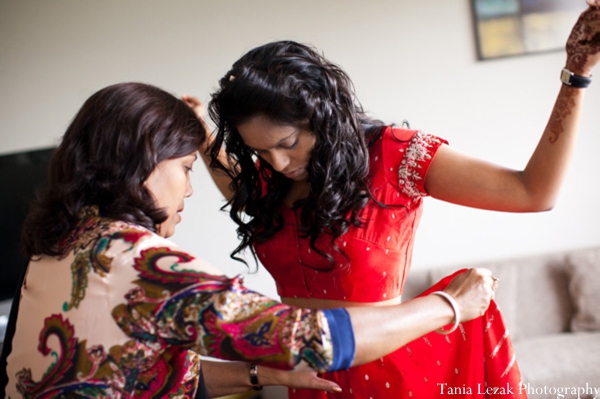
[255,127,447,302]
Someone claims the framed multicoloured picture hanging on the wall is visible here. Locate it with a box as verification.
[471,0,587,60]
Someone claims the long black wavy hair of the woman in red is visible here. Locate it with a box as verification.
[208,41,382,268]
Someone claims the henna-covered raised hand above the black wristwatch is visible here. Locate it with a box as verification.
[566,0,600,76]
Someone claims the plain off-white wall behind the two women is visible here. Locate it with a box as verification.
[0,0,600,296]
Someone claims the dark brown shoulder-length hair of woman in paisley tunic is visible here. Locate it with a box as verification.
[22,83,206,258]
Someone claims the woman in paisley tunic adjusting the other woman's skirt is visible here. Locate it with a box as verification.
[0,83,493,398]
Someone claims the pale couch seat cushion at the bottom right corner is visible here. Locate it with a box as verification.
[514,333,600,399]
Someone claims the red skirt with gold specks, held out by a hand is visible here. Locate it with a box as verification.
[289,275,527,399]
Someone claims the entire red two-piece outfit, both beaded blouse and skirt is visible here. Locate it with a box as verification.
[255,127,526,399]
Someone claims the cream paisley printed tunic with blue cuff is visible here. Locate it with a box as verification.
[6,208,354,398]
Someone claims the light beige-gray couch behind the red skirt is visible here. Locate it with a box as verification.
[403,247,600,399]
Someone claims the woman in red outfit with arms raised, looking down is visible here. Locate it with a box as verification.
[185,0,600,398]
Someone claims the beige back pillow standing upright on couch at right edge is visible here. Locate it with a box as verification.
[567,248,600,332]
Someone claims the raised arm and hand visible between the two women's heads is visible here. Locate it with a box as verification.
[181,95,233,201]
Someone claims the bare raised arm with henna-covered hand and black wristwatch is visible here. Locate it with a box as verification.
[425,0,600,212]
